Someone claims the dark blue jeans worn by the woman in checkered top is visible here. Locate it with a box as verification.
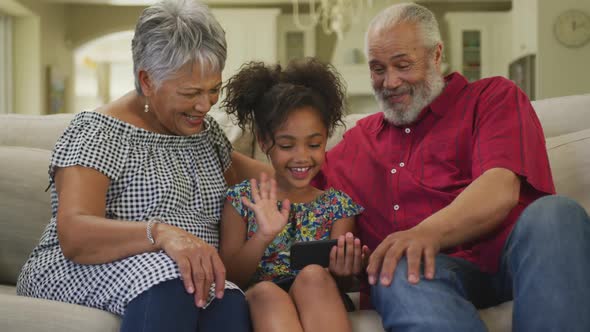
[121,279,251,332]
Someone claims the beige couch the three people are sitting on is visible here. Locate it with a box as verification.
[0,95,590,332]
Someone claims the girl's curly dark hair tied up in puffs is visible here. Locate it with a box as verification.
[221,58,345,147]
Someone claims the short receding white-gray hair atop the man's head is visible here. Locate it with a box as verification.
[365,3,442,54]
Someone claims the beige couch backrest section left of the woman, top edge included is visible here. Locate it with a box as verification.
[0,114,73,284]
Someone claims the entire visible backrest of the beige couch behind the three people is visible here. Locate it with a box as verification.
[0,95,590,284]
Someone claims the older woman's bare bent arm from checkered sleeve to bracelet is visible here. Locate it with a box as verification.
[55,166,162,264]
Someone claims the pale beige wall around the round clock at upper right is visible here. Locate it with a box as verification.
[536,0,590,99]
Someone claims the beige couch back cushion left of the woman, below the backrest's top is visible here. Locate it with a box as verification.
[0,146,51,284]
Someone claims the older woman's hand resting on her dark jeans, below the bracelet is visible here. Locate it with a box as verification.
[155,224,225,308]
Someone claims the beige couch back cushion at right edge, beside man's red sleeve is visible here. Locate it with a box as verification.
[547,129,590,211]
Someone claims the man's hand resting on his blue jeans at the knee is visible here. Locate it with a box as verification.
[367,227,441,286]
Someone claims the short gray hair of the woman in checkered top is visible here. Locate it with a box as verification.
[131,0,227,95]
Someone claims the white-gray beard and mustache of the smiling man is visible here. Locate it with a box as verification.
[373,63,445,126]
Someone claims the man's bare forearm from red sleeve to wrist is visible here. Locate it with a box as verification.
[416,168,520,249]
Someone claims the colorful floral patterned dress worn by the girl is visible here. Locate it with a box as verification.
[227,181,363,284]
